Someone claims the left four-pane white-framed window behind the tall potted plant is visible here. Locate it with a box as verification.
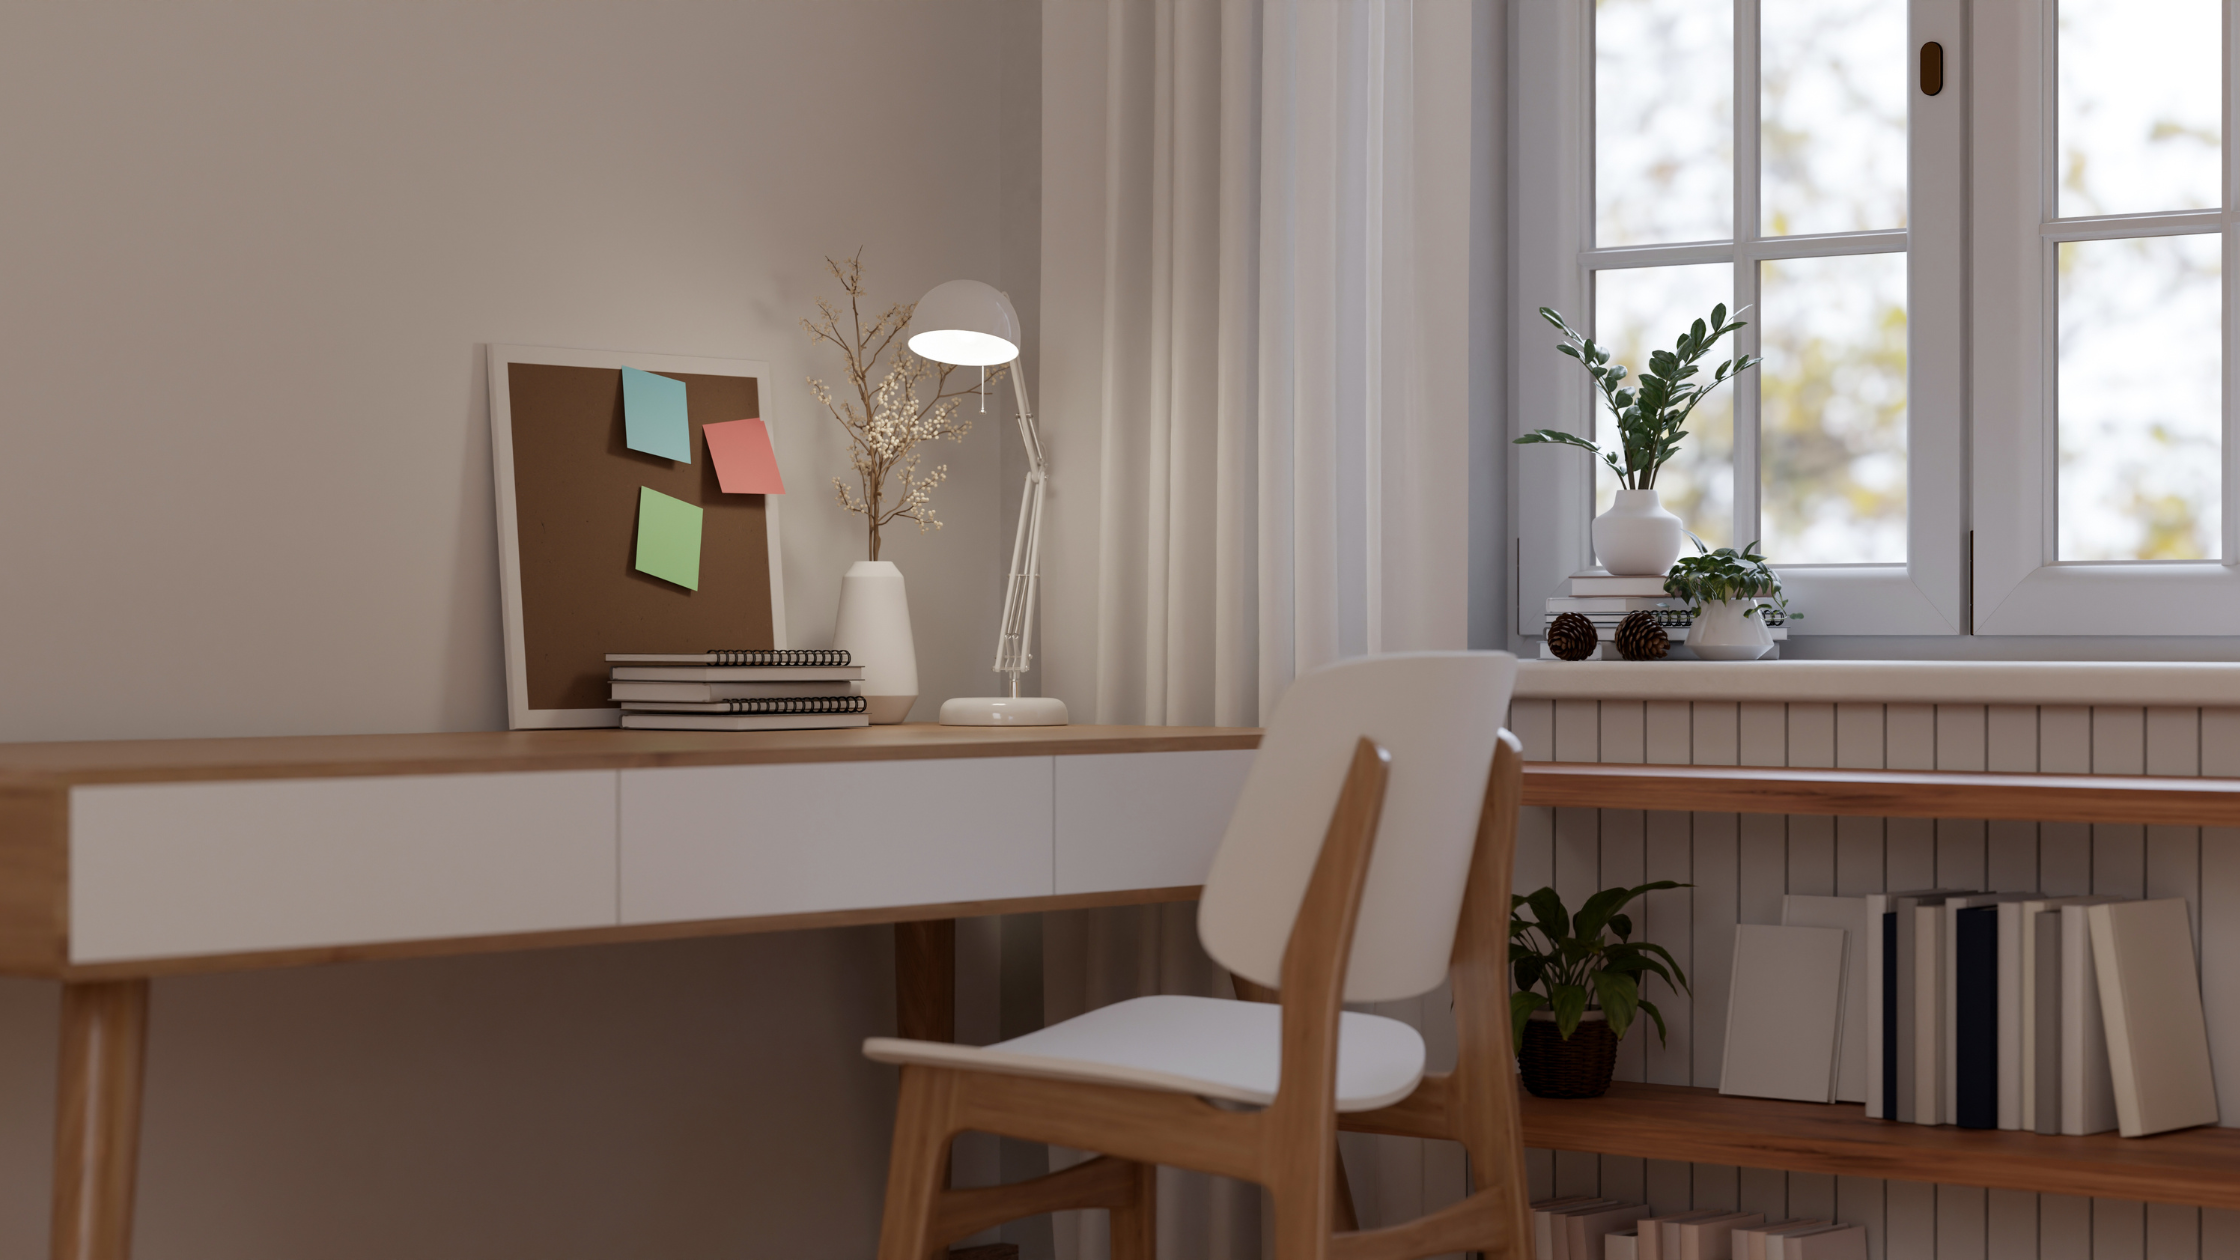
[1510,0,1964,634]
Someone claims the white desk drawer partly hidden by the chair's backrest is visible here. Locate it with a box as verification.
[1057,751,1252,892]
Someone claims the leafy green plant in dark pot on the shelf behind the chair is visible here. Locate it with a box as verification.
[1510,879,1689,1099]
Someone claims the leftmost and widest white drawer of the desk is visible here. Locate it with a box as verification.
[69,769,616,962]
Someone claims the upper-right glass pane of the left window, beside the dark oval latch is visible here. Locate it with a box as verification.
[1758,0,1906,235]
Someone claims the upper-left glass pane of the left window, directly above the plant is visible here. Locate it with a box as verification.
[1595,0,1734,246]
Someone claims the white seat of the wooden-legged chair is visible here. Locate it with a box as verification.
[862,995,1422,1112]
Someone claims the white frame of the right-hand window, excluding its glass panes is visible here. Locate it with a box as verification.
[1971,0,2240,634]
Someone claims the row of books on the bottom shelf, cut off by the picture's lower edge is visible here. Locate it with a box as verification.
[1532,1197,1866,1260]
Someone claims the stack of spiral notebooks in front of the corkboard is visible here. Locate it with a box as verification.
[607,648,871,731]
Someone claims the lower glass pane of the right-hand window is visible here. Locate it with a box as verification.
[2060,235,2224,560]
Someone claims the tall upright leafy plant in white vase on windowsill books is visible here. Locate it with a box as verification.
[1516,303,1758,576]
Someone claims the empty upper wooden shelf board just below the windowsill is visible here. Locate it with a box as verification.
[1525,762,2240,827]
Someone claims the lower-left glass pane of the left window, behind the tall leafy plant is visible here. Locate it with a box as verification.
[1594,262,1747,547]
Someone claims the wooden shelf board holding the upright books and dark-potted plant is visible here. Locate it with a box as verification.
[1523,1081,2240,1208]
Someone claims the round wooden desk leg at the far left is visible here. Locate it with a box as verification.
[52,980,148,1260]
